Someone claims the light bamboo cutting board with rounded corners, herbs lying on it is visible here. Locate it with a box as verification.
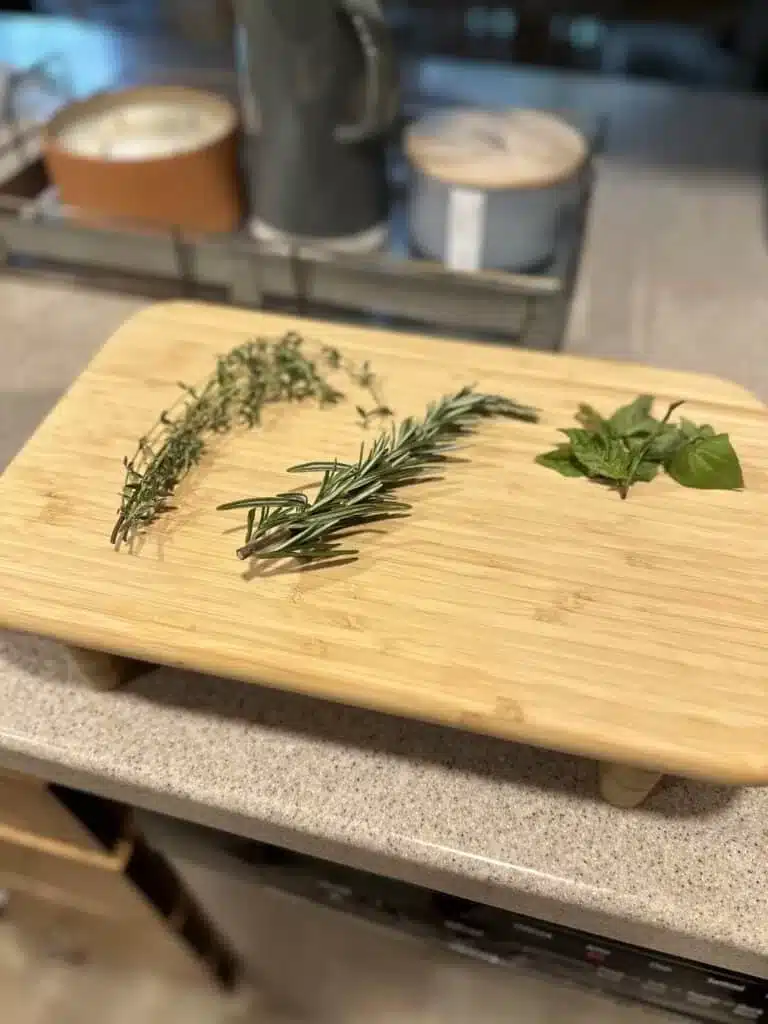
[0,303,768,783]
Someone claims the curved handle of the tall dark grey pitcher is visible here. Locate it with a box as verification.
[334,0,397,143]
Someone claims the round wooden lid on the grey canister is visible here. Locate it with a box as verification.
[406,109,588,188]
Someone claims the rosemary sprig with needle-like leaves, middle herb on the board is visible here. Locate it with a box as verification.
[219,387,538,562]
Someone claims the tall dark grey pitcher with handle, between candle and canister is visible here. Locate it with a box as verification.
[234,0,397,251]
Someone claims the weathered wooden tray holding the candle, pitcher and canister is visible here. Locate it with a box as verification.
[0,46,591,349]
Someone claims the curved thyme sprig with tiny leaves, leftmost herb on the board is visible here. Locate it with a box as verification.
[111,332,343,545]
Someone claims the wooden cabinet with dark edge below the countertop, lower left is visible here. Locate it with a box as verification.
[0,769,238,986]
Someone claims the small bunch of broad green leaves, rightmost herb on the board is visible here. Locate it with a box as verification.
[536,394,743,498]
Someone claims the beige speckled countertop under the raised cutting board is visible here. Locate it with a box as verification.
[0,64,768,977]
